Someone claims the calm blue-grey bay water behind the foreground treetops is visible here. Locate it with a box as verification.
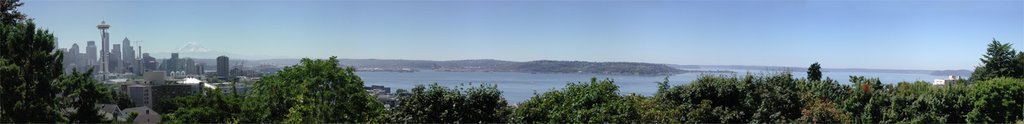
[356,70,945,104]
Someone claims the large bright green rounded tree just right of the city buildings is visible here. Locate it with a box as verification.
[244,56,384,123]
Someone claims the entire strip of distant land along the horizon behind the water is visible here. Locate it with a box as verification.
[178,58,972,77]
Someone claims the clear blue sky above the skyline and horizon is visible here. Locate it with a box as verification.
[19,0,1024,70]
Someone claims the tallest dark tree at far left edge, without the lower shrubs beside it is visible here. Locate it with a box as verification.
[0,15,63,123]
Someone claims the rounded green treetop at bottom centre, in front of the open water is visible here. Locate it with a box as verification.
[510,78,640,123]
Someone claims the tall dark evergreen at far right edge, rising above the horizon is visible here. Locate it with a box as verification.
[971,39,1024,81]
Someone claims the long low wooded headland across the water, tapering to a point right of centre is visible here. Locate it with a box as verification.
[233,58,694,76]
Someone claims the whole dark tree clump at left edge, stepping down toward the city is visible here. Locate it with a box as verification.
[0,4,130,123]
